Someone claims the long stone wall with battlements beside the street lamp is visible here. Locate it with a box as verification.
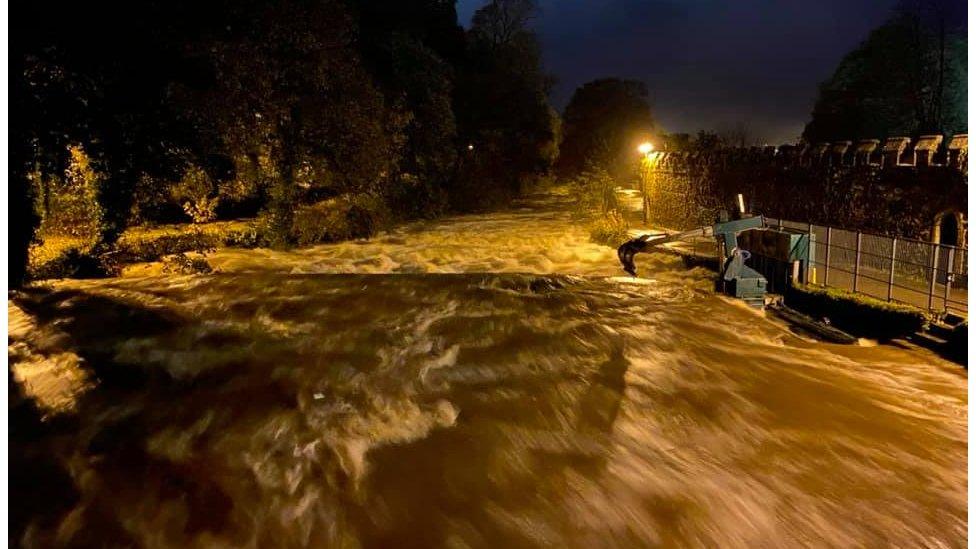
[641,135,968,246]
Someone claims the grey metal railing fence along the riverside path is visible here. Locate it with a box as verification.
[766,218,969,316]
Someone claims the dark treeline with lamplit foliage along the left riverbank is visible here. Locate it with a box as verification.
[9,0,557,284]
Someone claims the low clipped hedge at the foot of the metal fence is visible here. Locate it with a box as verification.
[785,286,927,340]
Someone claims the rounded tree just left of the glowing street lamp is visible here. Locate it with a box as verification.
[556,78,655,178]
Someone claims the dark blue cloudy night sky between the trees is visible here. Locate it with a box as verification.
[458,0,896,144]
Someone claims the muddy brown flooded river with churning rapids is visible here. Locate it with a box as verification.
[8,189,968,547]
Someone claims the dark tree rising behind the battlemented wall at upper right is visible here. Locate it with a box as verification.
[803,0,967,142]
